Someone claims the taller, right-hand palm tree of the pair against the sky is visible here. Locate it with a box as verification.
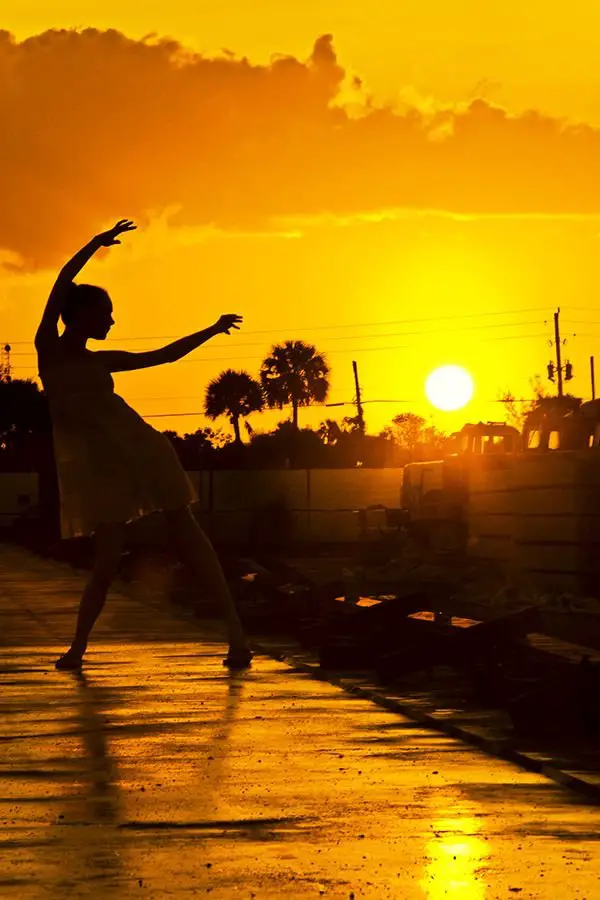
[260,341,329,431]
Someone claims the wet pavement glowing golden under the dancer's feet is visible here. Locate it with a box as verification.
[0,546,600,900]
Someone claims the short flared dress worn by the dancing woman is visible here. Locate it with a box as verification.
[39,350,197,538]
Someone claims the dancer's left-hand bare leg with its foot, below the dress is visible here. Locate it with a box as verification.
[56,522,125,669]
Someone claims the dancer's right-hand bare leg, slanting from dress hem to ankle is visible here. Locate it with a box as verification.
[165,506,248,654]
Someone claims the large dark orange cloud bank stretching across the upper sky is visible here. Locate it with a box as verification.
[0,29,600,270]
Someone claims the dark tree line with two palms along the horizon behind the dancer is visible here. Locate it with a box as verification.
[0,341,447,471]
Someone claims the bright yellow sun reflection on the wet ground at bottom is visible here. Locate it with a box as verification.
[421,817,490,900]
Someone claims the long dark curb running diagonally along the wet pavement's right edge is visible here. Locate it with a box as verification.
[250,637,600,803]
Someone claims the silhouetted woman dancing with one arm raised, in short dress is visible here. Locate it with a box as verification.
[35,219,252,669]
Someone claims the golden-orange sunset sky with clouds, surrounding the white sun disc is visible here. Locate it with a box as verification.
[0,0,600,432]
